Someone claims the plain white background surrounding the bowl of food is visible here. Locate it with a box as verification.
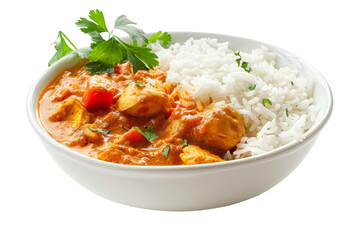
[0,0,360,240]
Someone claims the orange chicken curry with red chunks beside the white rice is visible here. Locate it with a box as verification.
[38,62,245,165]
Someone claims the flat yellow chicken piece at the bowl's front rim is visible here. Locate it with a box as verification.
[180,145,225,165]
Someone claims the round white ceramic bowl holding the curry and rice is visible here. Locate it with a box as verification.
[27,32,333,210]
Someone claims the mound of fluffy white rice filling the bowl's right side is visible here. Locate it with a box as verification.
[151,38,318,160]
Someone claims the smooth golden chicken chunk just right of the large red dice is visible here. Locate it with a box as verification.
[117,83,174,117]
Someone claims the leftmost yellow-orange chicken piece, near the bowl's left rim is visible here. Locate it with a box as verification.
[49,98,90,128]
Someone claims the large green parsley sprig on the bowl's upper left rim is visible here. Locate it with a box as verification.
[49,10,171,74]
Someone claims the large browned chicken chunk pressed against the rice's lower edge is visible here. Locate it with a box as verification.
[193,104,245,151]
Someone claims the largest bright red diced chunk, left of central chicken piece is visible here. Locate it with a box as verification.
[82,80,114,109]
